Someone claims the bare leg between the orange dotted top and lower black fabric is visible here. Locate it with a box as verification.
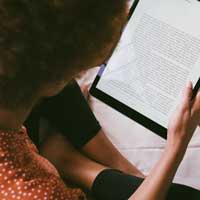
[41,133,108,190]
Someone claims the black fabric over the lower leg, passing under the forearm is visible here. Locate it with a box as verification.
[92,169,200,200]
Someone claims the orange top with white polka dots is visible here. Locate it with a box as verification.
[0,127,85,200]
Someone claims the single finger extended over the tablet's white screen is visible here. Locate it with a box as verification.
[182,81,193,110]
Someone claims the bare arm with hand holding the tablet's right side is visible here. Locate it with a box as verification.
[129,83,200,200]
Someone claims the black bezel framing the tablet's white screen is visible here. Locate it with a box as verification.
[90,0,200,139]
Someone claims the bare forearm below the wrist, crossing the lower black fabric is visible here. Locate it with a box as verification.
[130,140,184,200]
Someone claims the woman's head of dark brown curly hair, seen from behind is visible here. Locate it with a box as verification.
[0,0,126,109]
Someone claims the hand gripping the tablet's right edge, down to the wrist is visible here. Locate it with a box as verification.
[167,82,200,150]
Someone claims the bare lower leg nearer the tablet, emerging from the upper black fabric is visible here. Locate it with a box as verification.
[82,130,145,178]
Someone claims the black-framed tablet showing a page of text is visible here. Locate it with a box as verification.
[90,0,200,138]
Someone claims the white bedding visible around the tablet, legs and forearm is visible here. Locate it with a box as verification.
[79,68,200,189]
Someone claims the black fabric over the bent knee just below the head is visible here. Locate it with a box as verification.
[25,81,101,148]
